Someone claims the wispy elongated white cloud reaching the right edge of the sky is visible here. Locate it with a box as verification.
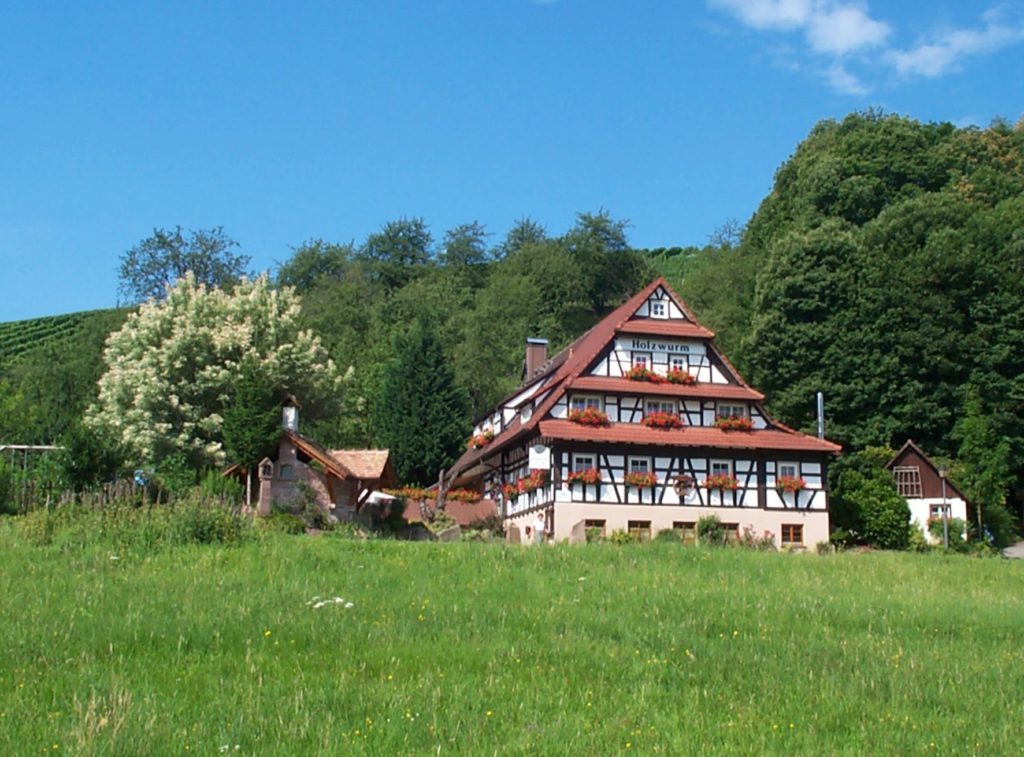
[889,11,1024,78]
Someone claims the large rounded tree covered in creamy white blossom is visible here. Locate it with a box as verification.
[86,274,341,466]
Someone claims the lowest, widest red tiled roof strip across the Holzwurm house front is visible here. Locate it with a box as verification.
[541,419,842,453]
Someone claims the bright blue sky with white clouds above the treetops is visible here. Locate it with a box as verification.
[0,0,1024,321]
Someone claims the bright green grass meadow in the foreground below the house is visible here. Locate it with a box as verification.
[0,522,1024,755]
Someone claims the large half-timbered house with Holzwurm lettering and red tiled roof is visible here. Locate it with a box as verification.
[451,279,840,546]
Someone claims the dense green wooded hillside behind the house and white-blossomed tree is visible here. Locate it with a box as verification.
[0,112,1024,532]
